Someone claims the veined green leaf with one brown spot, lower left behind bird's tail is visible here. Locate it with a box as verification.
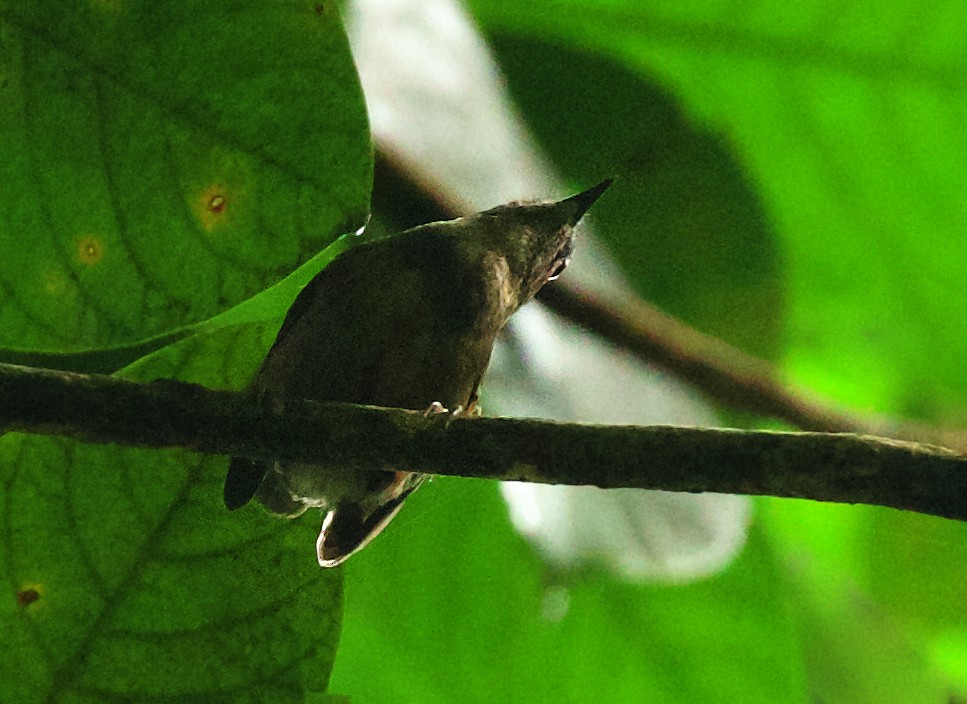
[0,324,342,702]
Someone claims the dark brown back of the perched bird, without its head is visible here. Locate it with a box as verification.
[225,227,498,515]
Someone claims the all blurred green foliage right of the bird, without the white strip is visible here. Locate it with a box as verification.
[333,0,967,704]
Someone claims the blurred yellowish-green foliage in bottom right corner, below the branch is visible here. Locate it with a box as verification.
[759,499,952,704]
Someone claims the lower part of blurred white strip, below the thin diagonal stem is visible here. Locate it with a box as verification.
[483,306,750,583]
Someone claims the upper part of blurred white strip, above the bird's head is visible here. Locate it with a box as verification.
[347,0,552,212]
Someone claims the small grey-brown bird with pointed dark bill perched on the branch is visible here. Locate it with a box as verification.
[225,180,611,567]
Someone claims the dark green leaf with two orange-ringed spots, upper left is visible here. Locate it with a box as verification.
[0,0,372,352]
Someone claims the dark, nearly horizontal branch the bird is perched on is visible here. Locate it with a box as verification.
[0,364,967,521]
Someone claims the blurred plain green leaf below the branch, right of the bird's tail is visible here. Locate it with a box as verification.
[331,478,809,704]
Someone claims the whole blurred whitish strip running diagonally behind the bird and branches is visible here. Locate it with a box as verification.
[347,0,750,584]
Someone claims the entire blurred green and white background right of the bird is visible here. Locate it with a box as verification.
[332,0,967,702]
